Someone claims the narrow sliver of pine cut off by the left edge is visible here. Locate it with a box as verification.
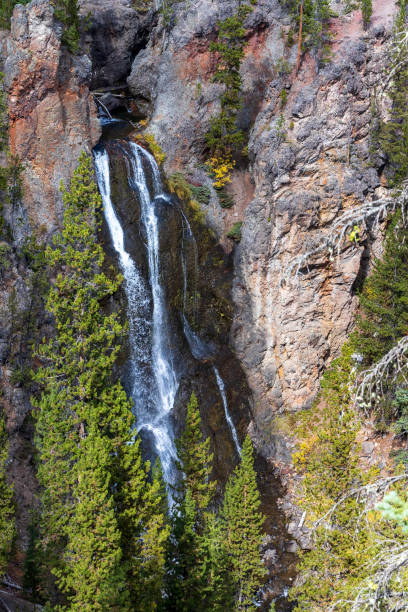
[0,413,16,576]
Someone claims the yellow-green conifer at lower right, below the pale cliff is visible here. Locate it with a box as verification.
[292,345,386,612]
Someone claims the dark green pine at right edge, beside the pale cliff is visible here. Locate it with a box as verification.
[355,211,408,364]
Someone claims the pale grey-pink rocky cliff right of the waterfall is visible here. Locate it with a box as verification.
[128,0,395,460]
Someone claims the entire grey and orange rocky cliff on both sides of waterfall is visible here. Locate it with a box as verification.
[0,0,402,604]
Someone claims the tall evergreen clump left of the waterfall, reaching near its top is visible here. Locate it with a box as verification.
[35,154,166,610]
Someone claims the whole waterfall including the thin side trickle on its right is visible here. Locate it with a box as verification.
[94,136,241,494]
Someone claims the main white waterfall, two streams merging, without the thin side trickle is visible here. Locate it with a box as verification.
[94,143,179,502]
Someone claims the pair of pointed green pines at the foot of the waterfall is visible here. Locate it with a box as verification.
[164,394,265,612]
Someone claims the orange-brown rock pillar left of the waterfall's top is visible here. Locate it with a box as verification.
[6,0,100,234]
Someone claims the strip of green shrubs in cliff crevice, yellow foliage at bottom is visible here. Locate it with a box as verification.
[206,2,255,187]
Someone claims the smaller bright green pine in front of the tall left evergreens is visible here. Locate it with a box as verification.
[56,432,127,612]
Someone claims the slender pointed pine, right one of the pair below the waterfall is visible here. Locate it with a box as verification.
[220,436,266,611]
